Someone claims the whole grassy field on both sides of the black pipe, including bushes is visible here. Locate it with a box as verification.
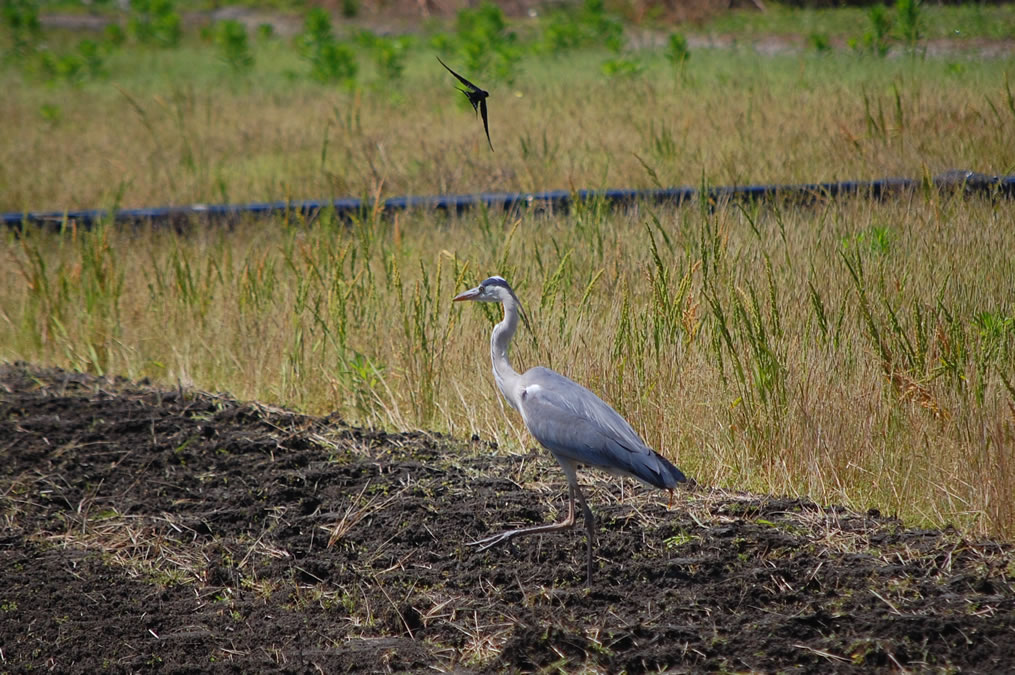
[0,3,1015,537]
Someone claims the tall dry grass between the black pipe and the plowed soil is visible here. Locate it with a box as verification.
[0,193,1015,534]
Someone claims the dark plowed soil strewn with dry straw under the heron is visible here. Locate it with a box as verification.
[0,364,1015,673]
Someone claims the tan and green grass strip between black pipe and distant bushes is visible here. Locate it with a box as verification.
[0,41,1015,211]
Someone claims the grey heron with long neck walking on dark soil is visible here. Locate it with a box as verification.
[455,276,686,584]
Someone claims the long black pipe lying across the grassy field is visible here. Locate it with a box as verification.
[0,170,1015,229]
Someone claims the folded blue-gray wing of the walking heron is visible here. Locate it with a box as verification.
[520,367,684,488]
